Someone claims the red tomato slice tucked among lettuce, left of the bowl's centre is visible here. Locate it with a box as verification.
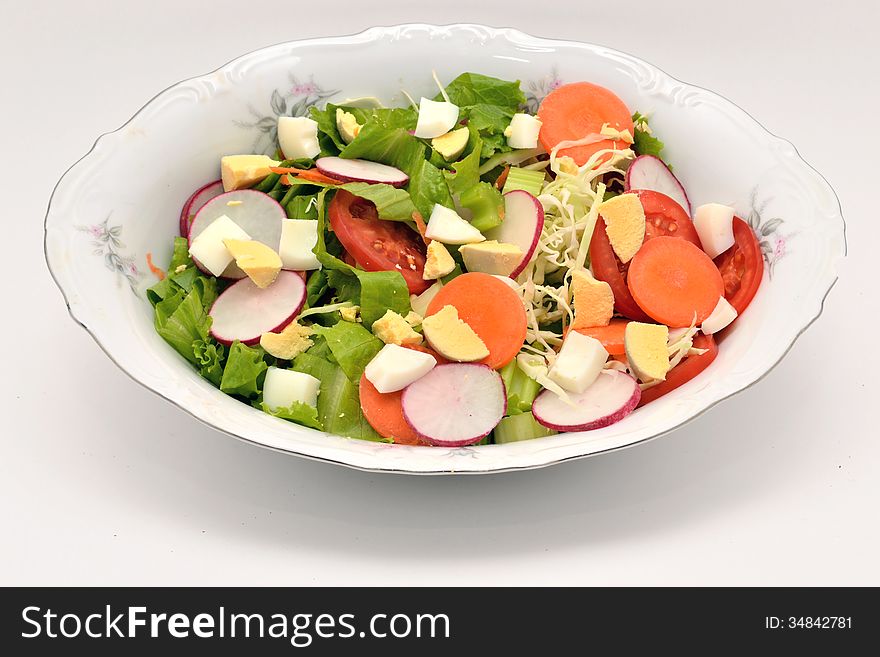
[328,189,432,294]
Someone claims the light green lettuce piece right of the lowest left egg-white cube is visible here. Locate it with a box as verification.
[293,352,385,442]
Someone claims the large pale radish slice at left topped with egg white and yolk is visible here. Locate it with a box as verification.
[189,189,287,279]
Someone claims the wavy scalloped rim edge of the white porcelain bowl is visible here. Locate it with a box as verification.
[44,23,846,474]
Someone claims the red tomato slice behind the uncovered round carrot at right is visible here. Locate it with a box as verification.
[590,189,703,322]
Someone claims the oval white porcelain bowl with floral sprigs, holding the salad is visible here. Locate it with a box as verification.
[46,25,845,473]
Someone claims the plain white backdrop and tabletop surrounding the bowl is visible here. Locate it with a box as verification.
[0,0,880,585]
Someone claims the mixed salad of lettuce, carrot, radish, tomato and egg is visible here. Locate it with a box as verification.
[146,72,764,447]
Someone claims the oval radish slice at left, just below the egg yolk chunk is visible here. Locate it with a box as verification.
[208,271,307,345]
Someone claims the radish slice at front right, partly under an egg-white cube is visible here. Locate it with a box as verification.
[532,370,642,431]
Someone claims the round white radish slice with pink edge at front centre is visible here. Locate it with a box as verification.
[401,363,507,447]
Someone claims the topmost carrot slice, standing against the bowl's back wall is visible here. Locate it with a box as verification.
[538,82,633,165]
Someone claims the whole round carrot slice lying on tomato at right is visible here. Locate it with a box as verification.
[627,237,724,326]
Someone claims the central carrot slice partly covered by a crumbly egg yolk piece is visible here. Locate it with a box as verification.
[427,272,526,369]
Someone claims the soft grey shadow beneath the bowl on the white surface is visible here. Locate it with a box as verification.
[63,336,806,561]
